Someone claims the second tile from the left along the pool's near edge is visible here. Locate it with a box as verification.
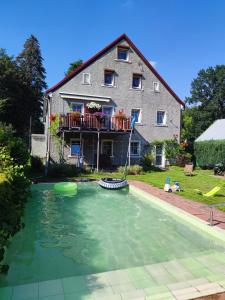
[12,283,38,300]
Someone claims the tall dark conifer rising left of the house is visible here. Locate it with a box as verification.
[17,35,47,132]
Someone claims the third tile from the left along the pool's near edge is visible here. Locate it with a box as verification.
[38,279,63,297]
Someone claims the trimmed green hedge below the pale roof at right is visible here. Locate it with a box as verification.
[194,140,225,167]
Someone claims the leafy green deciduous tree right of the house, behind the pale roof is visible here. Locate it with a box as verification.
[183,65,225,139]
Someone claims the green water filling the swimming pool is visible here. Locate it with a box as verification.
[0,183,224,286]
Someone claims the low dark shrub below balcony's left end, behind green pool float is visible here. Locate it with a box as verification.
[48,163,81,178]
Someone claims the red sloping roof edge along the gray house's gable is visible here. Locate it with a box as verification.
[46,34,185,106]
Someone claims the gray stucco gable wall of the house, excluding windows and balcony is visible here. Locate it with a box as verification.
[46,34,182,169]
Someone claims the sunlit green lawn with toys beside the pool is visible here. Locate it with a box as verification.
[81,167,225,211]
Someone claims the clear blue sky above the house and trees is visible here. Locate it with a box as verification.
[0,0,225,99]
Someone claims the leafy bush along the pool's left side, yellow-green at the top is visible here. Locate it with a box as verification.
[0,134,30,273]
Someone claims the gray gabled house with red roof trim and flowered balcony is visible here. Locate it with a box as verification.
[39,34,184,169]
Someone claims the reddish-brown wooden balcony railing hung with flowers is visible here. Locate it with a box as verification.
[59,113,131,131]
